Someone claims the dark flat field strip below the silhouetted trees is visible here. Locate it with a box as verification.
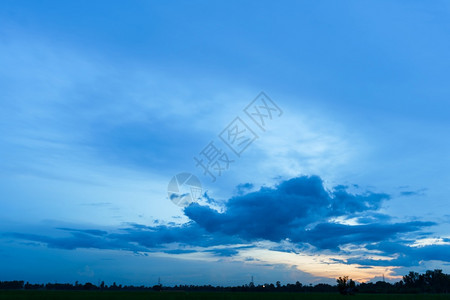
[0,291,450,300]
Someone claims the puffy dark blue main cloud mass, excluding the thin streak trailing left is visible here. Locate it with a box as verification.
[185,176,426,249]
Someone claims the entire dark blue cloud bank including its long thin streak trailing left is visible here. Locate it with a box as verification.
[0,176,442,265]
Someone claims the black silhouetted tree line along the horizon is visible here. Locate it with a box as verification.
[0,270,450,295]
